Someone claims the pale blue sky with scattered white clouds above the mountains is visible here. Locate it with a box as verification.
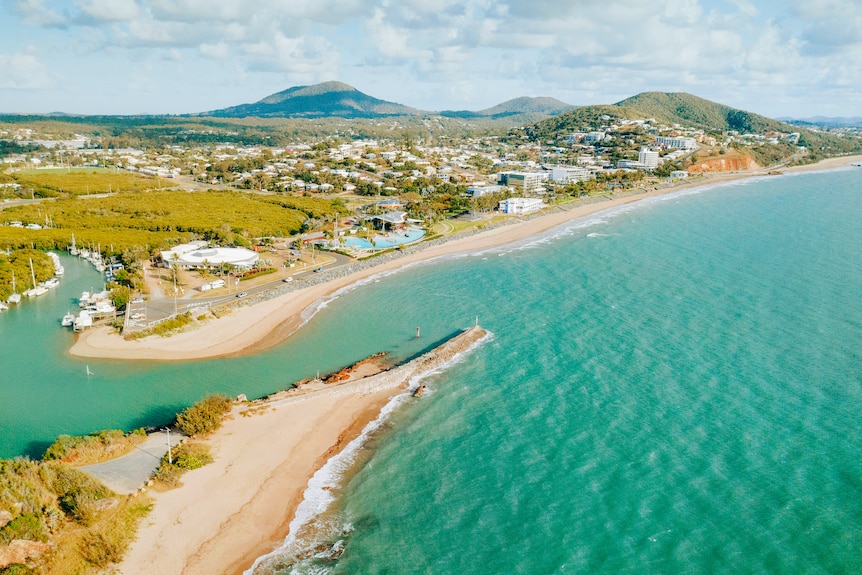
[0,0,862,118]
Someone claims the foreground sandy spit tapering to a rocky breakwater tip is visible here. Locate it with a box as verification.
[119,326,489,575]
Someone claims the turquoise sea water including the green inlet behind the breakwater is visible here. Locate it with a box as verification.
[0,169,862,574]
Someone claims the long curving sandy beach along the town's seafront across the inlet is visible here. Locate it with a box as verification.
[70,152,862,361]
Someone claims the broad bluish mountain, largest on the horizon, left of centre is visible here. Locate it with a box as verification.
[202,82,423,118]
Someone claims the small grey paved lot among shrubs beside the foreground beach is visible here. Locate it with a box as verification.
[78,431,182,494]
